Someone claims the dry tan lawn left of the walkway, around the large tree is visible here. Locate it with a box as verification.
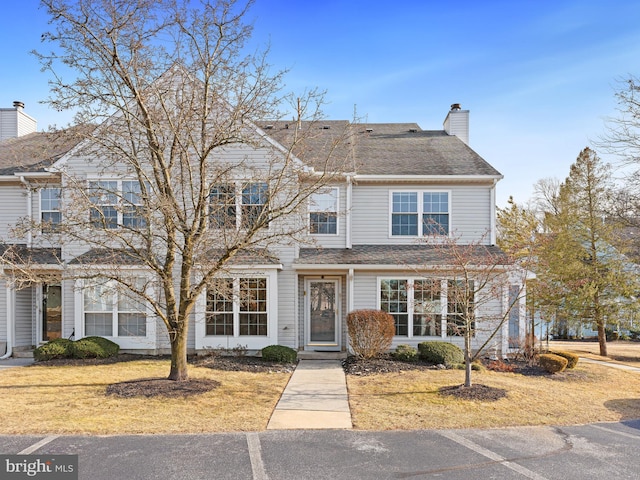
[0,360,290,435]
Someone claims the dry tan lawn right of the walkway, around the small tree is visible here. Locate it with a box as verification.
[347,364,640,430]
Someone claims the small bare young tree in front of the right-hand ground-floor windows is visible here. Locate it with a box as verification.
[413,235,529,387]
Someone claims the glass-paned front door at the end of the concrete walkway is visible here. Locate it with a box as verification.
[305,279,341,351]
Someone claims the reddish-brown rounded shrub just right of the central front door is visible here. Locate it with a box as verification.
[347,310,396,358]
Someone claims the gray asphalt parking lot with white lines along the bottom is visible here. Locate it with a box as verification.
[0,421,640,480]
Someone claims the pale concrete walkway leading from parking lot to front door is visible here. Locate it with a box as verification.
[267,360,353,430]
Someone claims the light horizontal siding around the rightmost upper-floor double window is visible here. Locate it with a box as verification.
[352,184,493,245]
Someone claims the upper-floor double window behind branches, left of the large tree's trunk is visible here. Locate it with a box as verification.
[89,180,146,229]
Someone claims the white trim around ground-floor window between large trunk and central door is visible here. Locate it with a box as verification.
[194,267,278,350]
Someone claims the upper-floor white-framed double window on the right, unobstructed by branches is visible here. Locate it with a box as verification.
[391,191,450,236]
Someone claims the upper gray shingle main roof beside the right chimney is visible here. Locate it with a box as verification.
[258,121,501,176]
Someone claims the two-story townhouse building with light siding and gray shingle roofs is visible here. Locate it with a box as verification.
[0,104,524,355]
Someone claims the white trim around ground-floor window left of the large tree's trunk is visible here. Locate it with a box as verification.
[73,270,156,350]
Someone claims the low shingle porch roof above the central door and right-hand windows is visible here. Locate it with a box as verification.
[294,244,510,268]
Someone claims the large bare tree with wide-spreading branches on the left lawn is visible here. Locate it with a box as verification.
[26,0,345,380]
